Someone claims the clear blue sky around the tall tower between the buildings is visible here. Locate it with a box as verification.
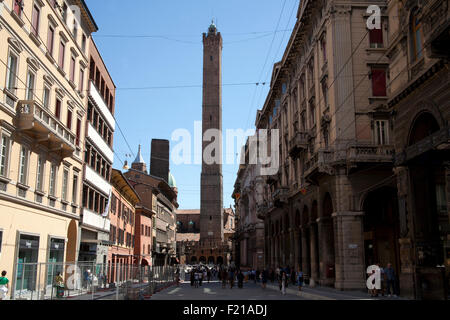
[86,0,299,209]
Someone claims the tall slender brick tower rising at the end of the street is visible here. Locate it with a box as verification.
[200,23,223,242]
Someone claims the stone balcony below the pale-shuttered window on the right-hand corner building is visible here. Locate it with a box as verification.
[346,145,395,164]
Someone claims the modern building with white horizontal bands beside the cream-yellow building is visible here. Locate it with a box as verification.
[79,39,116,263]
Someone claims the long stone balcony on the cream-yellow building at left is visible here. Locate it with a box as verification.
[16,100,75,159]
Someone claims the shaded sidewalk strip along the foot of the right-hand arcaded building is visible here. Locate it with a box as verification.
[267,282,407,300]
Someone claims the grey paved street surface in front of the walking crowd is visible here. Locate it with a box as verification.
[151,280,305,301]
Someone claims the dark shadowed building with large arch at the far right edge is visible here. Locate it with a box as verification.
[386,0,450,299]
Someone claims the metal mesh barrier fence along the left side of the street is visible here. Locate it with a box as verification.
[8,262,176,300]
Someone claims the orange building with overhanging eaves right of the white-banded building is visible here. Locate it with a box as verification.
[108,169,140,283]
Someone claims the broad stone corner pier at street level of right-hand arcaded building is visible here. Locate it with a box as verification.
[333,211,367,290]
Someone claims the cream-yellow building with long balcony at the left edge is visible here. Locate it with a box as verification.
[0,0,97,295]
